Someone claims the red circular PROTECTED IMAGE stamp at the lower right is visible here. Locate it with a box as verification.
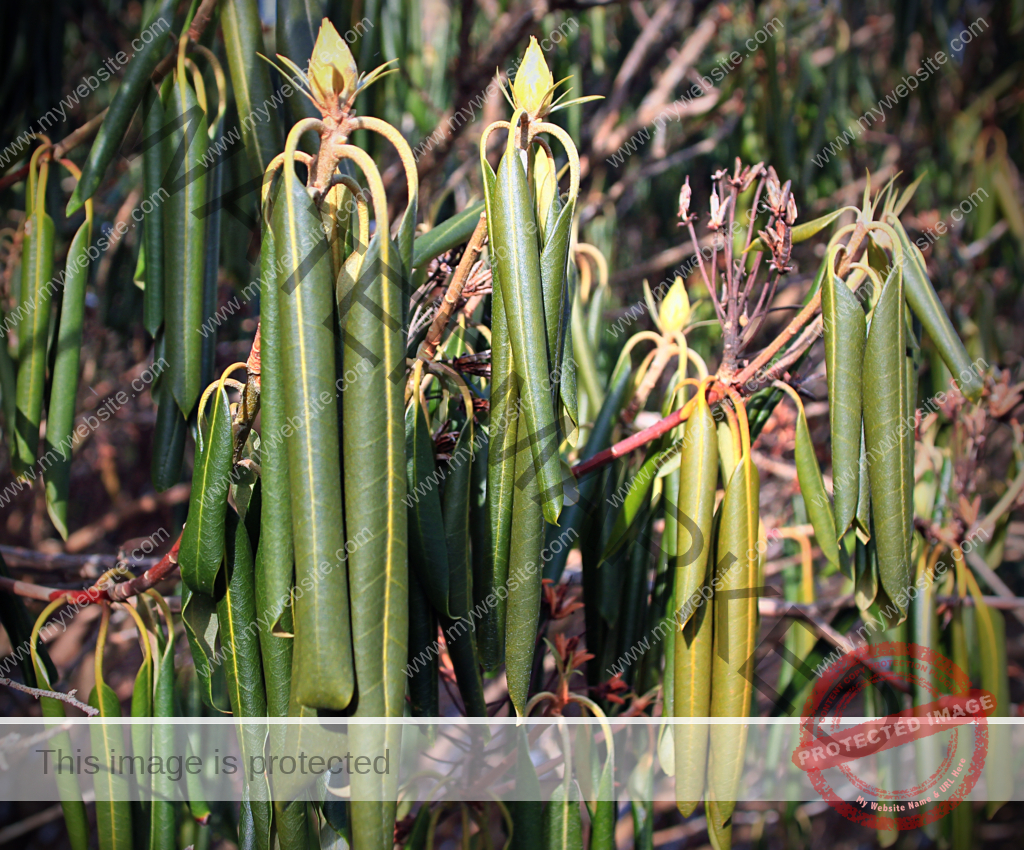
[793,641,995,830]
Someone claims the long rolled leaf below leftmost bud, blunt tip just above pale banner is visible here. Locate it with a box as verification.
[272,171,356,710]
